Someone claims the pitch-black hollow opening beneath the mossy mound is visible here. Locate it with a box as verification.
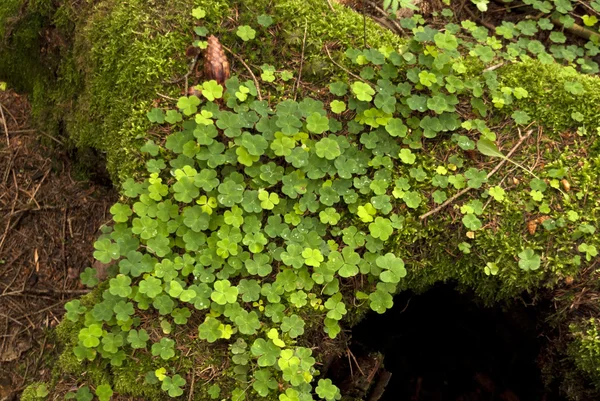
[328,285,561,401]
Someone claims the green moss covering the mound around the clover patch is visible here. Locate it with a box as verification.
[0,0,600,399]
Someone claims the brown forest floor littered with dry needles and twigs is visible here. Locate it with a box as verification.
[0,90,117,400]
